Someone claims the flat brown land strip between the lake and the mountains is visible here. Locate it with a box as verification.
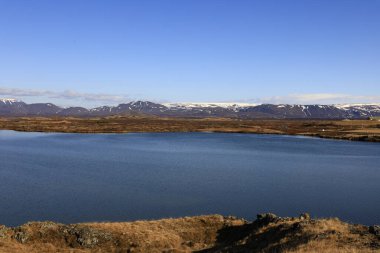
[0,116,380,141]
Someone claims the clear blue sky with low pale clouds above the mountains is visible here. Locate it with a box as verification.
[0,0,380,107]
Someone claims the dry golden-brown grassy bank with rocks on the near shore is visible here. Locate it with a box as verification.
[0,214,380,253]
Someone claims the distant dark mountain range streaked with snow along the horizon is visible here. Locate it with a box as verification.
[0,99,380,119]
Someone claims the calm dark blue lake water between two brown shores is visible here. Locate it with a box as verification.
[0,131,380,225]
